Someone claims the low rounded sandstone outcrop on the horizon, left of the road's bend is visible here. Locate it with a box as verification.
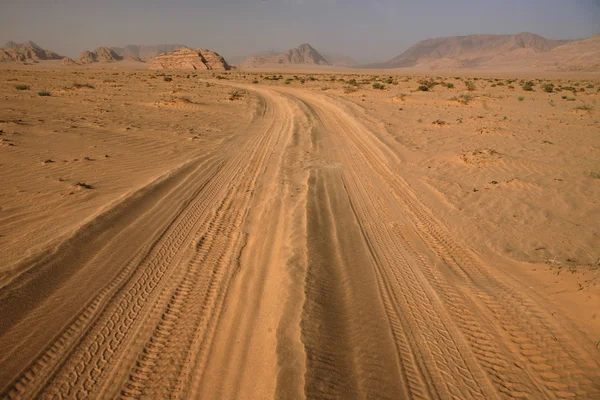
[150,48,231,70]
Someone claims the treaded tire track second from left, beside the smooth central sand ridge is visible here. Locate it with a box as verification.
[122,92,278,398]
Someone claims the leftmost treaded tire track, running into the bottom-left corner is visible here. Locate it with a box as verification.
[0,90,280,398]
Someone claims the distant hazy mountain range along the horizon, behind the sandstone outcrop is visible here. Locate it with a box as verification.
[0,32,600,71]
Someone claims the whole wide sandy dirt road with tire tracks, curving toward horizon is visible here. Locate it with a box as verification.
[0,82,600,399]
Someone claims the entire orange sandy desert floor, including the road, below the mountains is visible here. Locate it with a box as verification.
[0,64,600,399]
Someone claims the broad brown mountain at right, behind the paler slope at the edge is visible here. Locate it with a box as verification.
[370,32,568,68]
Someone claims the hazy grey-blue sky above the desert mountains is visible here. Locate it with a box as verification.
[0,0,600,61]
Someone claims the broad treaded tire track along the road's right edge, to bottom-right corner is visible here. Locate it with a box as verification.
[296,91,599,398]
